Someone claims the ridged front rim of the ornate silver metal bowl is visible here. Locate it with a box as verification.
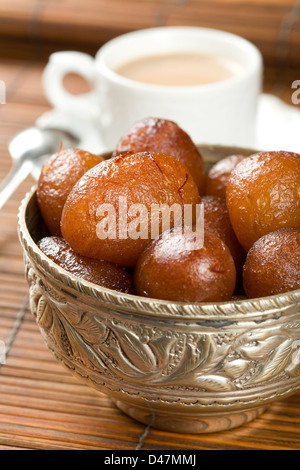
[18,185,300,321]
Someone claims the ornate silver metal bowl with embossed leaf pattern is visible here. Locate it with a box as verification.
[18,147,300,433]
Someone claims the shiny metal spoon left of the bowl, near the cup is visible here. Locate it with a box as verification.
[0,127,78,209]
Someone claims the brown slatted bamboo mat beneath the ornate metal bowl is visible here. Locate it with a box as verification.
[0,0,300,451]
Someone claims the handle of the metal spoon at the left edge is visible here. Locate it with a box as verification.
[0,161,32,210]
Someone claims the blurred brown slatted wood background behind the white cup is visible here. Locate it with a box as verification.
[0,0,300,104]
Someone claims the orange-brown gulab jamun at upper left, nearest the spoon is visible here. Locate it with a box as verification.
[37,149,103,235]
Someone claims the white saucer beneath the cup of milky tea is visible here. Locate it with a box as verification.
[37,94,300,158]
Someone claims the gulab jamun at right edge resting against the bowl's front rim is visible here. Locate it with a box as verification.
[243,227,300,298]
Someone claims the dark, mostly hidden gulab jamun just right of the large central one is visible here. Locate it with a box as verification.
[201,196,246,277]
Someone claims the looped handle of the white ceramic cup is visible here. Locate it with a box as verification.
[42,51,100,120]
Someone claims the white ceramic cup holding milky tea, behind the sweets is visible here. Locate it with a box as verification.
[43,27,263,150]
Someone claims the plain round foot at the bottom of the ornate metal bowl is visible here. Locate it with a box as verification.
[113,400,267,434]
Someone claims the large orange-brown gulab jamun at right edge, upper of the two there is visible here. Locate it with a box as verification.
[226,151,300,251]
